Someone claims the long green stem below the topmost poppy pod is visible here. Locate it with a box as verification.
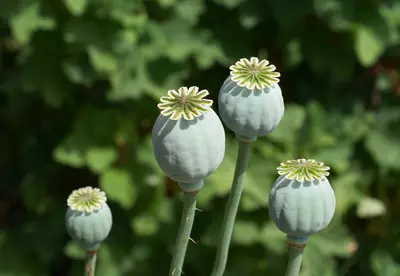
[211,142,251,276]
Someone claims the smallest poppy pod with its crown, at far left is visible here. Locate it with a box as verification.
[65,187,112,251]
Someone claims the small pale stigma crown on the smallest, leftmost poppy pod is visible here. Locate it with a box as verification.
[67,187,107,213]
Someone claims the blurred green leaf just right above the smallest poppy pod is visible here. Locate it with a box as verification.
[100,168,137,209]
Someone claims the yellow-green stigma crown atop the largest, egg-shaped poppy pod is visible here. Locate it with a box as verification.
[157,86,213,120]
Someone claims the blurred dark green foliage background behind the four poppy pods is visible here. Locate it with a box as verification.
[0,0,400,276]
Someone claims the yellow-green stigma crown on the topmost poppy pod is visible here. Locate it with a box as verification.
[229,57,281,90]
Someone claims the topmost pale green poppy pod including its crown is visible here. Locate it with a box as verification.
[218,57,285,141]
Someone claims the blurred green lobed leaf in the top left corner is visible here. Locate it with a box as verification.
[10,2,56,44]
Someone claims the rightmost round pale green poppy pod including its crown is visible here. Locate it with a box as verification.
[268,159,336,237]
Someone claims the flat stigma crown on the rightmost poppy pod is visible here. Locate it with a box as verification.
[277,158,329,182]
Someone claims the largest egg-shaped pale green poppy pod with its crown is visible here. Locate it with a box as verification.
[152,86,225,192]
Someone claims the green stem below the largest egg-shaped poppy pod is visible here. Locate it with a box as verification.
[169,192,197,276]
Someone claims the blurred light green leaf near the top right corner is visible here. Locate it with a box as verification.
[355,26,385,67]
